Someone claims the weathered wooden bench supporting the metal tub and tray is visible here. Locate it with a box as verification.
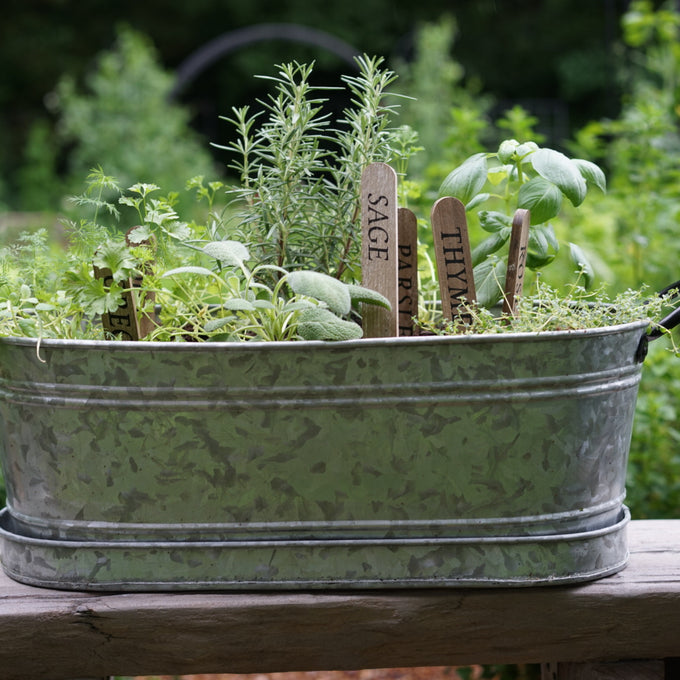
[0,520,680,680]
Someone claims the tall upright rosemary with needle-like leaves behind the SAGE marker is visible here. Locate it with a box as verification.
[223,57,409,279]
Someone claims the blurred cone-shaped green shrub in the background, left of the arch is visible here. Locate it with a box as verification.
[50,28,213,202]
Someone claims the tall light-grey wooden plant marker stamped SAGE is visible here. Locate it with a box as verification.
[361,163,399,338]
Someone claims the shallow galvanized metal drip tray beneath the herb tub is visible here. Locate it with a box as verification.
[0,504,629,591]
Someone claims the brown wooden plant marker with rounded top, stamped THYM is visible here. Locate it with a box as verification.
[432,196,477,323]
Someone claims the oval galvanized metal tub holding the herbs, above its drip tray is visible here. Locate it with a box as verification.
[0,322,647,587]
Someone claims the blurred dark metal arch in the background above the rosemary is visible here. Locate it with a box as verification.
[171,24,360,97]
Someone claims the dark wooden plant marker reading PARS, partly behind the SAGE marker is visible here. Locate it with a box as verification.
[397,208,418,335]
